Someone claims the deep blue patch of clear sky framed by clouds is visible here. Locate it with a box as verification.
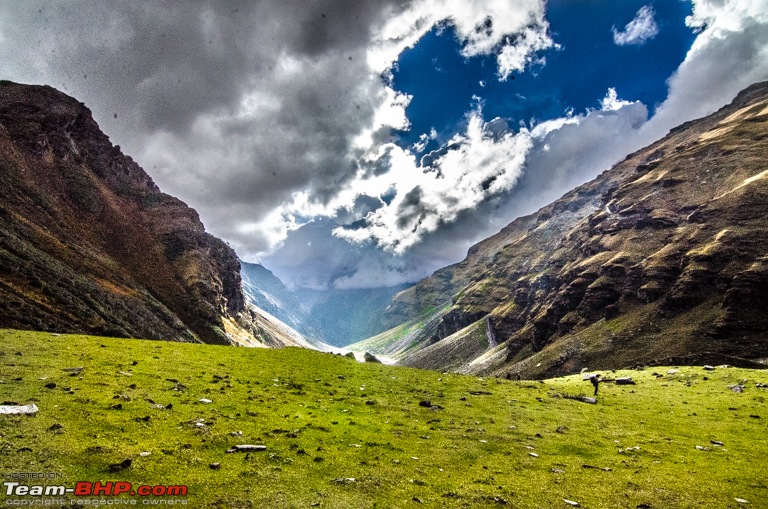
[392,0,695,150]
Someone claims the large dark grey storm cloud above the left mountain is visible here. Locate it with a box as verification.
[0,0,399,252]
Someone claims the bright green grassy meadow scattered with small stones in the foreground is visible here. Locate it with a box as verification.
[0,330,768,509]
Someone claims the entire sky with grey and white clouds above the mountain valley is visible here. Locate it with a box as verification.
[0,0,768,288]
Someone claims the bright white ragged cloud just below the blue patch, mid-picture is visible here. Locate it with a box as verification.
[333,109,531,254]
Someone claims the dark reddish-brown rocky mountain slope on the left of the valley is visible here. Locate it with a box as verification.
[0,81,304,346]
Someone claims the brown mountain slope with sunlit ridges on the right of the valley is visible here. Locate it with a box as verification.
[358,83,768,377]
